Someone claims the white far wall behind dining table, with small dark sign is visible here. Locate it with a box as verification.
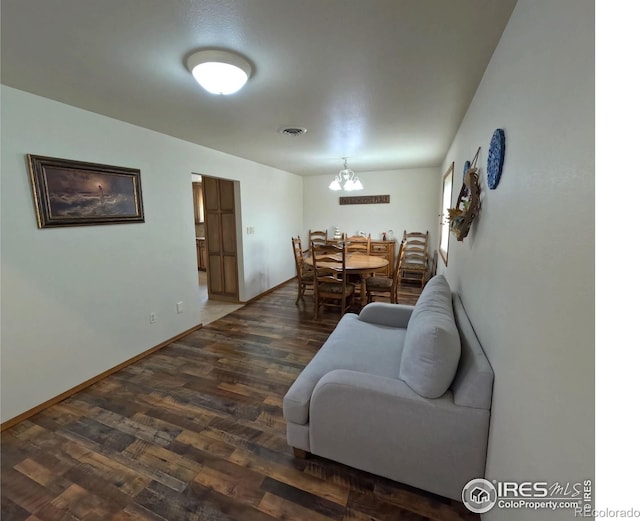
[300,168,442,251]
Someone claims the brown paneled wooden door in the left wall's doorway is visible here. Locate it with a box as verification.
[202,176,239,301]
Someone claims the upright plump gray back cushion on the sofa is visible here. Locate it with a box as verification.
[400,275,460,398]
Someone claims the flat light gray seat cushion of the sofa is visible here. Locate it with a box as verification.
[283,313,406,424]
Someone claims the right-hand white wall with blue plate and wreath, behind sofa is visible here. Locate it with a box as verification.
[440,0,597,521]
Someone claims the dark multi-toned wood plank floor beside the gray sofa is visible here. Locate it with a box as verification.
[1,283,478,521]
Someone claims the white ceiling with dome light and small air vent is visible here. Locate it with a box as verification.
[0,0,516,175]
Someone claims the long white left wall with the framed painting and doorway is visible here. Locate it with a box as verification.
[0,86,302,421]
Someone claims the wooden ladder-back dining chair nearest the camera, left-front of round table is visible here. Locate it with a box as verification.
[311,243,355,320]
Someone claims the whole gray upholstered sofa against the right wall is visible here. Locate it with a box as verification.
[283,275,493,501]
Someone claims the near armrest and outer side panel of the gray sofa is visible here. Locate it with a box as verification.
[309,369,490,498]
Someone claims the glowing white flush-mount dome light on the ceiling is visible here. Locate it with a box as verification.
[187,49,251,94]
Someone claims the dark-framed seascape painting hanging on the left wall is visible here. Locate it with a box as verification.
[27,154,144,228]
